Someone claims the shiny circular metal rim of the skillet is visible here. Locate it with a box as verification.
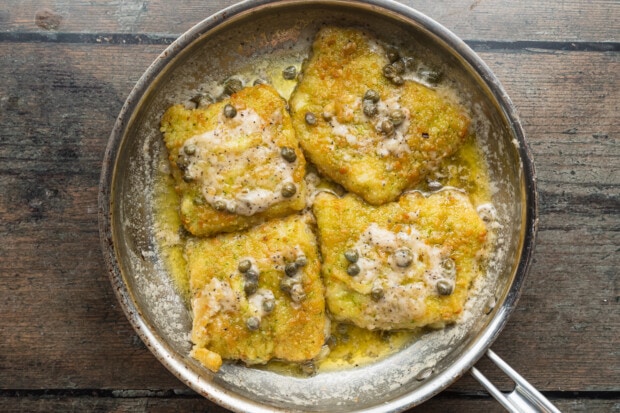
[98,0,538,412]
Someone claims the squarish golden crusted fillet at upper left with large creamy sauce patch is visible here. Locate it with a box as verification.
[161,85,306,236]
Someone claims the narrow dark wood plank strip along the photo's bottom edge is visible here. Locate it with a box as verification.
[0,394,620,413]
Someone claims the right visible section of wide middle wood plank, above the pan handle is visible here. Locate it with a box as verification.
[454,52,620,390]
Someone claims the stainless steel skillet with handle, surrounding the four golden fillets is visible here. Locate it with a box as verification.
[99,0,556,412]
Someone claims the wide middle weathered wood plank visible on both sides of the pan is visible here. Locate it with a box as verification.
[0,43,620,394]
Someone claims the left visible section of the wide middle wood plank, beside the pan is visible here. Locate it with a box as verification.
[0,44,179,388]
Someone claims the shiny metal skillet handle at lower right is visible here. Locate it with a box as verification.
[470,350,560,413]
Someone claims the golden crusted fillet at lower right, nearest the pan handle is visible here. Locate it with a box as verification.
[313,190,487,330]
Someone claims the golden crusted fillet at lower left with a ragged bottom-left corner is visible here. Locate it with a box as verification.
[185,215,327,370]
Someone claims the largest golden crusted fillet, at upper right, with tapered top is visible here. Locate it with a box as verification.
[290,27,470,205]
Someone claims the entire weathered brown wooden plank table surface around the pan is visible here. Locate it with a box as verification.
[0,0,620,413]
